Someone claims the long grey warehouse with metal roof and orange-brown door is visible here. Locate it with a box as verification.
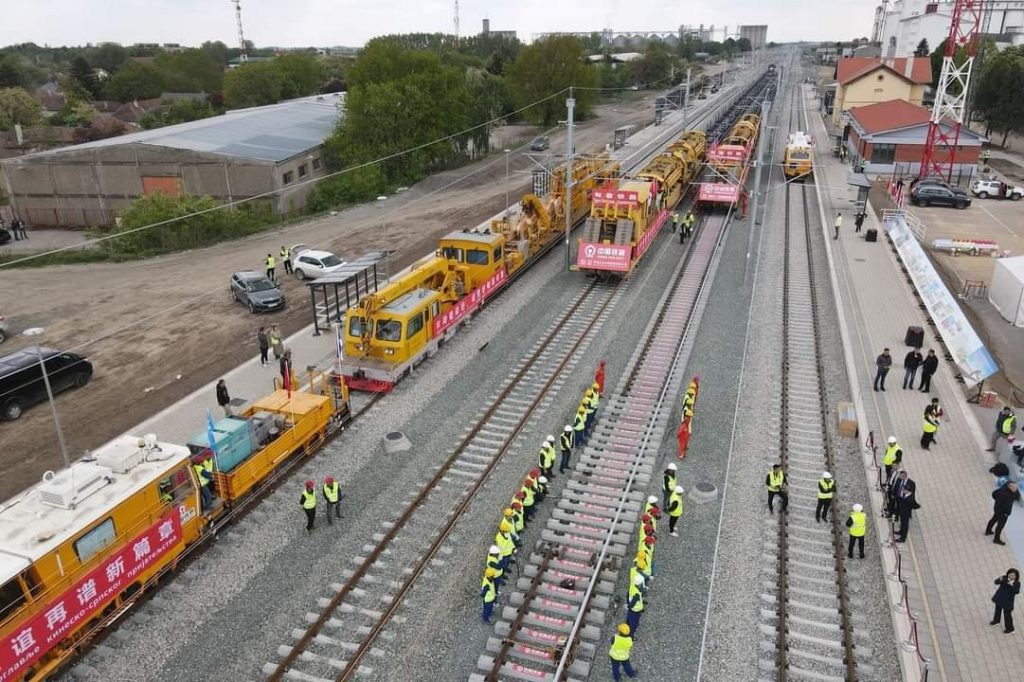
[0,94,344,227]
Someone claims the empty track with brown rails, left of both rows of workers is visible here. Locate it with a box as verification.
[263,283,623,682]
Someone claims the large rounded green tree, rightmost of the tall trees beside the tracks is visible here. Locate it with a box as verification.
[507,36,599,127]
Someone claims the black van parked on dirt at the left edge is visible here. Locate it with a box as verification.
[0,348,92,421]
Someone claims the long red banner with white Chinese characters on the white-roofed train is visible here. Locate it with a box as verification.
[0,510,181,682]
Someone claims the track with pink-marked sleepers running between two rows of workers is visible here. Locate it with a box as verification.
[469,208,728,682]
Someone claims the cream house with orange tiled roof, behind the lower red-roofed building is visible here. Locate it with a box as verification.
[833,57,932,127]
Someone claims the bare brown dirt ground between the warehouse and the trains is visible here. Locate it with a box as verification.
[0,94,653,500]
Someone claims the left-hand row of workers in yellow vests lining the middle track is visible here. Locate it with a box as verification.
[480,376,604,624]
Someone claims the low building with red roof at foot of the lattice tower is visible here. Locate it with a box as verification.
[846,99,985,177]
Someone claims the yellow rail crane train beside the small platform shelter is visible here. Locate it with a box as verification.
[341,156,618,392]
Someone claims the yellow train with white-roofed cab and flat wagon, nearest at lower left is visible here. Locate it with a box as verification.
[0,374,349,682]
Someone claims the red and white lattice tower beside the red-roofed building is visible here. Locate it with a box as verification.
[918,0,985,180]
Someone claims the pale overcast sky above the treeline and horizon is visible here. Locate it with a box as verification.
[0,0,879,45]
